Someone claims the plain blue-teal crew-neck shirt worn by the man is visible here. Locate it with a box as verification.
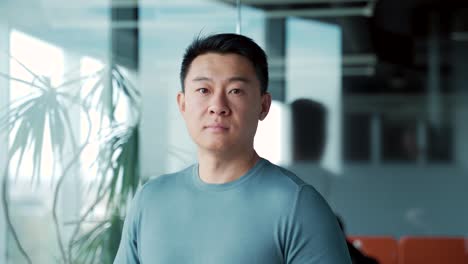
[114,159,351,264]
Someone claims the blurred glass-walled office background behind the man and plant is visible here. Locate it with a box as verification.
[0,0,468,264]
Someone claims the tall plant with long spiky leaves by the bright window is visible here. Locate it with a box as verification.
[0,53,141,264]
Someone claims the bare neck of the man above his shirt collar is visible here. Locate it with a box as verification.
[198,149,260,184]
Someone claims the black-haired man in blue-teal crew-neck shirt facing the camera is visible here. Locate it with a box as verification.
[114,34,350,264]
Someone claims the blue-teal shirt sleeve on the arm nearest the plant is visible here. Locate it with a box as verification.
[114,190,142,264]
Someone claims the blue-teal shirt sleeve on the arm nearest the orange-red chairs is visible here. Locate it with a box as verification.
[285,185,351,264]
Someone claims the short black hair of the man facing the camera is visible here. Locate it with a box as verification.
[180,33,268,94]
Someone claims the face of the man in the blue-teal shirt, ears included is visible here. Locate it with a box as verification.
[177,53,271,154]
